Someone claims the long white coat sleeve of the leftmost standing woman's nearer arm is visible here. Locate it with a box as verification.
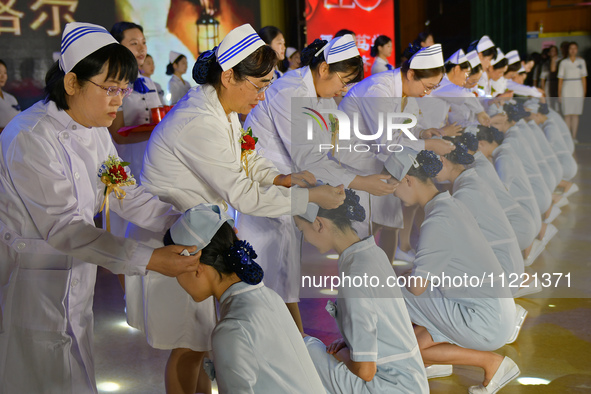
[5,133,153,275]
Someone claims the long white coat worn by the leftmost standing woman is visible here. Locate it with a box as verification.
[0,101,178,394]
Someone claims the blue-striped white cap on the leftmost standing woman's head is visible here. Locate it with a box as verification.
[60,22,118,74]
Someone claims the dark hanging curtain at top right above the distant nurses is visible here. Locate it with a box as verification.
[470,0,527,57]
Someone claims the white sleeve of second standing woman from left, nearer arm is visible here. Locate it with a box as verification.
[173,117,308,217]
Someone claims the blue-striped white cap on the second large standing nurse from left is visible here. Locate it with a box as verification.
[215,23,266,71]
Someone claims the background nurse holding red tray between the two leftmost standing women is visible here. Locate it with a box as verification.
[109,22,162,179]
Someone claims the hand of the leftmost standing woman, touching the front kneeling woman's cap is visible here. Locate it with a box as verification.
[146,245,201,277]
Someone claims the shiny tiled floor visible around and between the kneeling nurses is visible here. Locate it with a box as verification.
[95,145,591,394]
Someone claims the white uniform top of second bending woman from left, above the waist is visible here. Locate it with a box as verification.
[141,84,308,217]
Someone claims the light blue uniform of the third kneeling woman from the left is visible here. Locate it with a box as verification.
[403,192,516,351]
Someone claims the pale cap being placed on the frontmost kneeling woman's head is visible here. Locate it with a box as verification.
[170,204,234,253]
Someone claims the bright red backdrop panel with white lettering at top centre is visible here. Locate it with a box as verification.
[306,0,396,76]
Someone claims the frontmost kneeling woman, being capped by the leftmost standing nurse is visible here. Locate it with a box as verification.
[165,204,324,394]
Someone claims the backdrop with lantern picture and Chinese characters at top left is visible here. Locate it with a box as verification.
[0,0,260,109]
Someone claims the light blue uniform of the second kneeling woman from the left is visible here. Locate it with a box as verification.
[305,237,429,394]
